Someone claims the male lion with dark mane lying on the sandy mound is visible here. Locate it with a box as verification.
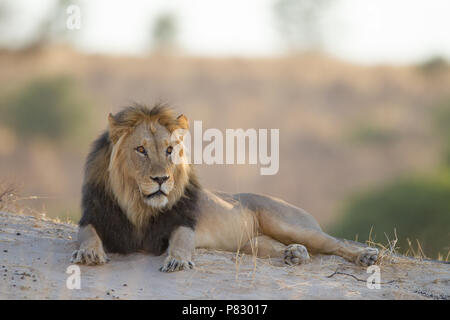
[71,104,378,272]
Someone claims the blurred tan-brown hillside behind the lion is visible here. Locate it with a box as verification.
[0,47,450,255]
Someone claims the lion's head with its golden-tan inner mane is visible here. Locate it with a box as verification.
[108,105,192,225]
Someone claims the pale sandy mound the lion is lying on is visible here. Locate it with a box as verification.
[0,213,450,299]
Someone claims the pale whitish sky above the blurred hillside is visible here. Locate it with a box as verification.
[0,0,450,64]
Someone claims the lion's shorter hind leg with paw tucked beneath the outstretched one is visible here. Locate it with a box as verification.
[241,235,309,265]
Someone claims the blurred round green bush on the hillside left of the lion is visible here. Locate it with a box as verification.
[0,76,89,139]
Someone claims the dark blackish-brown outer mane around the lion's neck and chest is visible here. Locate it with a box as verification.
[79,132,201,255]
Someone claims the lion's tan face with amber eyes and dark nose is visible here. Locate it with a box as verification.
[123,123,182,209]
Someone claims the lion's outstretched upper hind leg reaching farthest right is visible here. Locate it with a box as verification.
[259,212,378,266]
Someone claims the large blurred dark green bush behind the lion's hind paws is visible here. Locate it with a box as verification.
[331,170,450,258]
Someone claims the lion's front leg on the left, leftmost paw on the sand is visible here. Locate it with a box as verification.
[71,224,109,265]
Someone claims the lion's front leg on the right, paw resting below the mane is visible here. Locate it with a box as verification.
[159,227,195,272]
